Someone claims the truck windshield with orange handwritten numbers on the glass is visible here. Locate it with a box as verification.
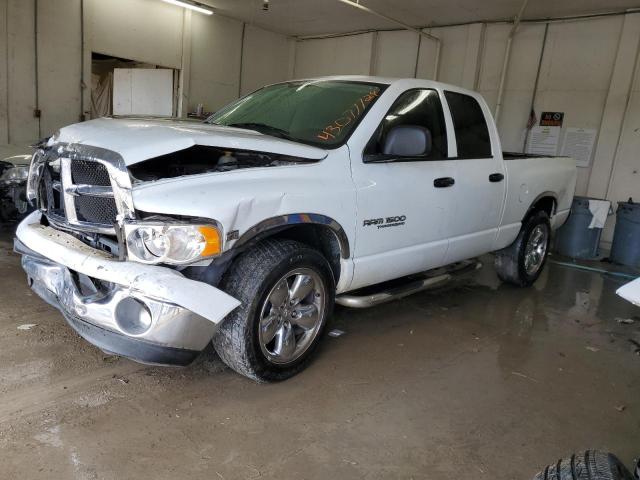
[206,80,386,148]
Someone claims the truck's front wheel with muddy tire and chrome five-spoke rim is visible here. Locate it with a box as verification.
[212,239,335,383]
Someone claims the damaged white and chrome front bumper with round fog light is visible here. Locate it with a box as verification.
[15,212,240,365]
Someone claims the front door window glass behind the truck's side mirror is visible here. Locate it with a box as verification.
[365,89,447,160]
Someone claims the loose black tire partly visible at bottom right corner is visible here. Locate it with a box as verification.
[534,450,634,480]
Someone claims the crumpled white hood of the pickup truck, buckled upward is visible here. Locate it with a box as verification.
[56,118,327,166]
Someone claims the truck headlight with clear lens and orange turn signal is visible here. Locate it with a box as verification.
[124,223,222,265]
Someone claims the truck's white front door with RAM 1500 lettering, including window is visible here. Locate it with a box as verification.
[350,89,458,289]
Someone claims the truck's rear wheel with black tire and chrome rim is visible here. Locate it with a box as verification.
[495,210,551,287]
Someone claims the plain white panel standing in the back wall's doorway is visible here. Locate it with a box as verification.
[113,68,173,117]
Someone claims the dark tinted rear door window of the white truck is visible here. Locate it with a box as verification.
[444,92,491,158]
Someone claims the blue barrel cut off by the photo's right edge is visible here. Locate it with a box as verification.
[609,199,640,268]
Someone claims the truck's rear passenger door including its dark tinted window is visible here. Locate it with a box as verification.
[444,91,506,263]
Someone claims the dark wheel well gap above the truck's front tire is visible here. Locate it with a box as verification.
[261,224,342,284]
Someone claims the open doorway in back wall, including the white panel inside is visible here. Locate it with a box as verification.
[91,52,180,118]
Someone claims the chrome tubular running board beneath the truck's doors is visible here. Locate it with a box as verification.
[336,260,482,308]
